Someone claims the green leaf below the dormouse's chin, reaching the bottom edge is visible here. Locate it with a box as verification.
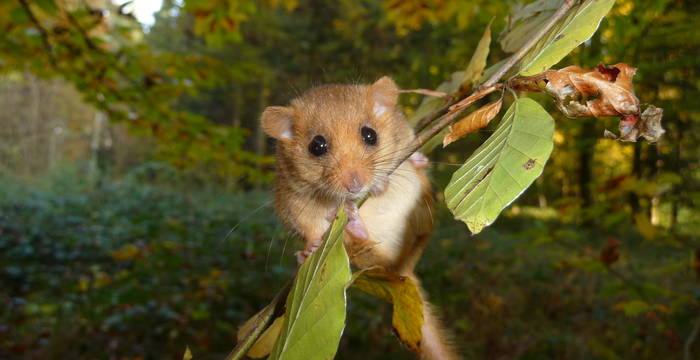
[270,206,350,360]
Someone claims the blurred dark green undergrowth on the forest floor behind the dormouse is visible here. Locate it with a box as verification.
[0,164,700,359]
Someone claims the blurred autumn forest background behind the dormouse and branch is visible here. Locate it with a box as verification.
[0,0,700,359]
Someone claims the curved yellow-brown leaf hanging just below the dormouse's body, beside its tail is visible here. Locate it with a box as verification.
[353,269,423,351]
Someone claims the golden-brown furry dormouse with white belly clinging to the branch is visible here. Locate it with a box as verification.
[262,77,457,359]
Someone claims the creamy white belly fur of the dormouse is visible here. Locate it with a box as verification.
[360,162,421,260]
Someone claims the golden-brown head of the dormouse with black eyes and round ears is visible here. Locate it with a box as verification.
[262,77,414,199]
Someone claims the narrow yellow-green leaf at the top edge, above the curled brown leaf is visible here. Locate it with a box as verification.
[519,0,615,76]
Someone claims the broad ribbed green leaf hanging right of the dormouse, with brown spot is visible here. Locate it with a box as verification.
[445,98,554,233]
